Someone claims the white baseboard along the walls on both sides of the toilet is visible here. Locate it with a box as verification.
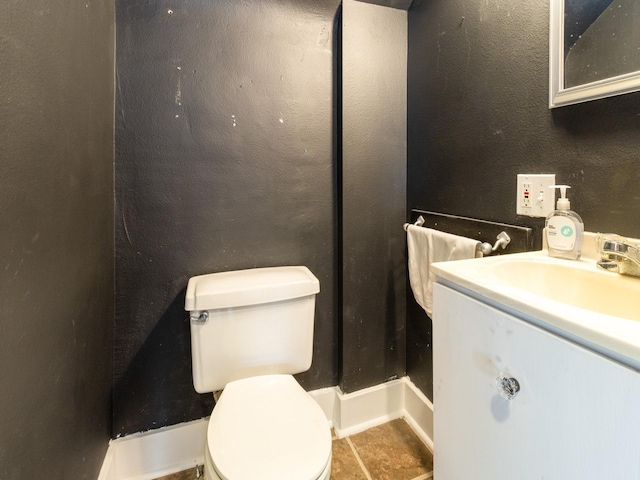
[98,377,433,480]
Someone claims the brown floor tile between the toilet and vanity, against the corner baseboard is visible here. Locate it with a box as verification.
[350,419,433,480]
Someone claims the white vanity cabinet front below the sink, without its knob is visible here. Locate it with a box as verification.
[433,284,640,480]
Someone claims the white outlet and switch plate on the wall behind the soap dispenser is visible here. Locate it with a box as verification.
[516,173,556,217]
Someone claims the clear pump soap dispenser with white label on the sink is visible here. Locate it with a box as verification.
[545,185,584,260]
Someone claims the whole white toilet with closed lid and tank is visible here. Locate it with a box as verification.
[185,266,331,480]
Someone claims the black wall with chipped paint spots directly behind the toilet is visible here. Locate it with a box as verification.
[114,0,339,435]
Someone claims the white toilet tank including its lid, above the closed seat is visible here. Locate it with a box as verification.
[185,266,320,393]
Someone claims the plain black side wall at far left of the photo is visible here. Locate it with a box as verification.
[0,0,114,480]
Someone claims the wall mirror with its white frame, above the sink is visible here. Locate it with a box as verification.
[549,0,640,108]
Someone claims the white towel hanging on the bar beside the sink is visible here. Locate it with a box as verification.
[407,225,482,317]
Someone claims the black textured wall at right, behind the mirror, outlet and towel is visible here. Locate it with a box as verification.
[407,0,640,396]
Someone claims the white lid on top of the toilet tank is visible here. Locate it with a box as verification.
[184,266,320,311]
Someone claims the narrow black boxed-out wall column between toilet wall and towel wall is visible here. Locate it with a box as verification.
[340,0,407,392]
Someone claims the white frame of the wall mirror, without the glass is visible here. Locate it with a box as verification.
[549,0,640,108]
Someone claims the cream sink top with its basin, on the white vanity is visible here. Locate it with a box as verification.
[432,250,640,371]
